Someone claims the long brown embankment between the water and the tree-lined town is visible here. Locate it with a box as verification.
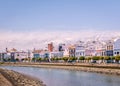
[1,62,120,75]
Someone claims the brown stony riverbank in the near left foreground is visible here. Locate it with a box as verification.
[0,68,46,86]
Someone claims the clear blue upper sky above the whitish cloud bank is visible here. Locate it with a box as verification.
[0,0,120,32]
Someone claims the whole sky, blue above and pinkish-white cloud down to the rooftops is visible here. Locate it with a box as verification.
[0,0,120,49]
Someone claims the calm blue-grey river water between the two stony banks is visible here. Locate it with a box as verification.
[0,66,120,86]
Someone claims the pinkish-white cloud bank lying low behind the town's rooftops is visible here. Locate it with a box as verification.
[0,30,120,50]
